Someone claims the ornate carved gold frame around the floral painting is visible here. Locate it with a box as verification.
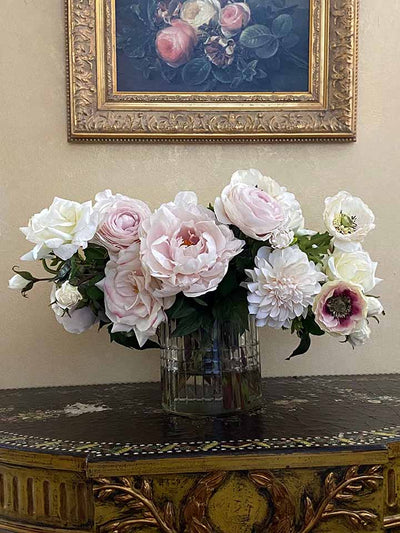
[65,0,359,142]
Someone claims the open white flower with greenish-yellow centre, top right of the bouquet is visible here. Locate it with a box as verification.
[323,191,375,251]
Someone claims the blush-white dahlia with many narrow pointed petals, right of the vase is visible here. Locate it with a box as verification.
[246,246,325,329]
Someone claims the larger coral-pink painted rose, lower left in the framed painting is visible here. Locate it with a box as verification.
[156,19,197,68]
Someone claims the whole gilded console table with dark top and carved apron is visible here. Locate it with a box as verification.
[0,375,400,533]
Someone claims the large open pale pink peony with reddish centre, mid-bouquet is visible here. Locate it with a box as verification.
[139,192,244,297]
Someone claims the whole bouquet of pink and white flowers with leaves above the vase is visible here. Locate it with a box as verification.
[9,170,384,357]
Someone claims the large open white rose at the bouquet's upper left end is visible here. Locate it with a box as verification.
[20,197,97,261]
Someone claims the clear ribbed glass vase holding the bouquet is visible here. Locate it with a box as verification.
[159,317,261,416]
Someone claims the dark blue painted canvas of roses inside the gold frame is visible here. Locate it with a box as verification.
[116,0,309,91]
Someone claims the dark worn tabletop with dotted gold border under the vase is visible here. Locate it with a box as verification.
[0,374,400,461]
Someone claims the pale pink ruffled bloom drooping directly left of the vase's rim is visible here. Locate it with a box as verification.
[97,243,174,346]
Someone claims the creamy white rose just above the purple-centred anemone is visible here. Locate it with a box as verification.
[326,250,382,292]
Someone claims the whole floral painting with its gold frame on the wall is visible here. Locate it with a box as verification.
[66,0,358,141]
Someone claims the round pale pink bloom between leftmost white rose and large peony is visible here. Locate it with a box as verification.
[93,189,151,254]
